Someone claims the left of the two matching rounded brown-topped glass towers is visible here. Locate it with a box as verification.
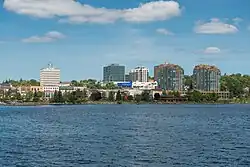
[154,63,184,91]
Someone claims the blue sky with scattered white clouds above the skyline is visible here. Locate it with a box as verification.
[0,0,250,81]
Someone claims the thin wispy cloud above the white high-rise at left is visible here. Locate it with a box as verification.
[22,31,65,43]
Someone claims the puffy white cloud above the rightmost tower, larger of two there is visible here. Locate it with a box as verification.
[194,18,239,34]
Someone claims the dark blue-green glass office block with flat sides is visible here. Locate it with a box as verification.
[103,64,125,82]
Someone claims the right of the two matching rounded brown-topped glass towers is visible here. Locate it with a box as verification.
[193,65,221,91]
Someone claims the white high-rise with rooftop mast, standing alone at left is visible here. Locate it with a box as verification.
[40,64,60,87]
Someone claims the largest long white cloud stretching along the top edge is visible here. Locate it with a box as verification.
[3,0,181,23]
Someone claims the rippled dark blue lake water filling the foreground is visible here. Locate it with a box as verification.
[0,105,250,167]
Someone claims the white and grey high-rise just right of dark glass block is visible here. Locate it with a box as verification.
[129,67,149,82]
